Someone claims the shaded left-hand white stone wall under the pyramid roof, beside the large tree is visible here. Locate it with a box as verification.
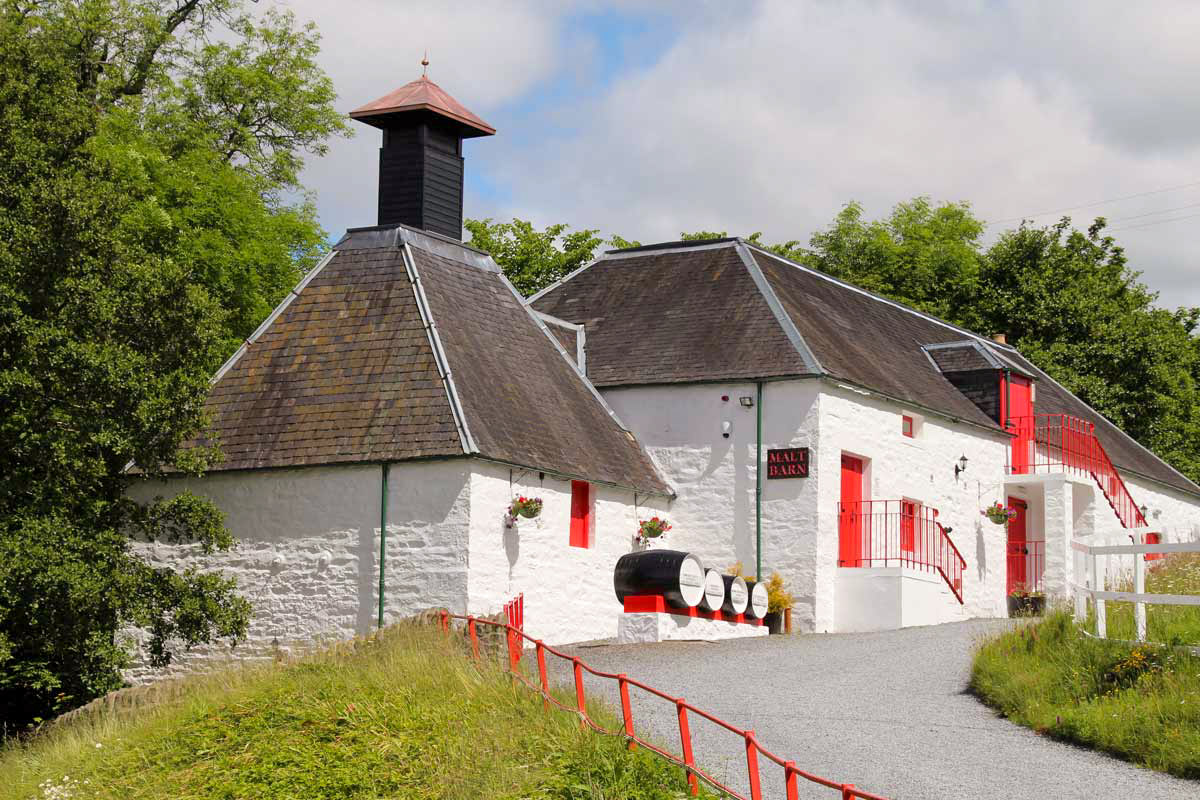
[128,459,470,681]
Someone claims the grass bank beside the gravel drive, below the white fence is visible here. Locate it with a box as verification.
[971,612,1200,778]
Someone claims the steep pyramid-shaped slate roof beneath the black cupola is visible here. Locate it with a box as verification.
[192,220,671,494]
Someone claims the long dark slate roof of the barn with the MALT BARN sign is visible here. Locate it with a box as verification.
[529,240,1200,494]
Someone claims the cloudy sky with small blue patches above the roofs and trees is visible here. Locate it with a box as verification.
[260,0,1200,307]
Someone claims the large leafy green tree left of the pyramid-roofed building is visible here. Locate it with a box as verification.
[0,0,344,724]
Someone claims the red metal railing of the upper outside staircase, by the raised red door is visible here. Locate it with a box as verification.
[1008,414,1146,528]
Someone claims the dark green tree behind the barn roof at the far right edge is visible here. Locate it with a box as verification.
[978,218,1200,480]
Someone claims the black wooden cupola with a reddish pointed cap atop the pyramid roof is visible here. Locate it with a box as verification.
[350,69,496,239]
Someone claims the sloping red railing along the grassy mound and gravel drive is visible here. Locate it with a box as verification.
[440,612,887,800]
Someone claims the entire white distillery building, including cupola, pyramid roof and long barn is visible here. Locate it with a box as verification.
[132,78,1200,678]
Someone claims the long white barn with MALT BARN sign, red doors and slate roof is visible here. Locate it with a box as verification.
[529,239,1200,631]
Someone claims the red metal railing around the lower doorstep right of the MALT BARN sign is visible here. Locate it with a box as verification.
[838,500,966,603]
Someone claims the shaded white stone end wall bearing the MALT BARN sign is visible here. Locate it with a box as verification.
[604,380,818,630]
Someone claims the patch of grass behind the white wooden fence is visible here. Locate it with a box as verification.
[1087,553,1200,645]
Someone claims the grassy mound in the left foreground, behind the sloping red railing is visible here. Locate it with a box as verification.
[0,626,705,800]
